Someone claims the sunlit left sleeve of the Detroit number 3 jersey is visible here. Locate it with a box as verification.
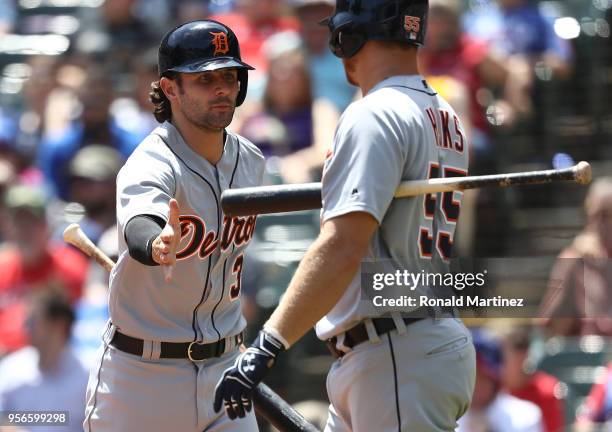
[117,143,176,234]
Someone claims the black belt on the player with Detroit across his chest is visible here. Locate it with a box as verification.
[110,331,243,362]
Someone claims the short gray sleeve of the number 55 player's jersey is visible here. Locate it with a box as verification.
[321,100,406,224]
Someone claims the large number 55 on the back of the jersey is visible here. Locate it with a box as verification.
[419,162,467,260]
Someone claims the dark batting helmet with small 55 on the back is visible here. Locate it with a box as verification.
[322,0,428,58]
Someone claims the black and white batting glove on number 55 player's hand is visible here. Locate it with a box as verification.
[213,330,285,420]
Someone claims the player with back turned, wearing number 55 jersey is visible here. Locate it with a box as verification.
[215,0,475,432]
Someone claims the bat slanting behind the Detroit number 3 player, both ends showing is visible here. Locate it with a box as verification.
[64,223,320,432]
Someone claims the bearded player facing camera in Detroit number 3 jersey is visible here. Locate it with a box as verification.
[84,21,264,432]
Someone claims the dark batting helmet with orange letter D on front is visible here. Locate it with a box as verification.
[157,20,255,106]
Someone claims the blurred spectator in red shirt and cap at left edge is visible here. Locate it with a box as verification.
[0,185,88,355]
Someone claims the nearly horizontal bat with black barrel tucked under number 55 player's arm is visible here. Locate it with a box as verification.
[221,162,591,216]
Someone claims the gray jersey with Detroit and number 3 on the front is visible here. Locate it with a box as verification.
[109,122,264,342]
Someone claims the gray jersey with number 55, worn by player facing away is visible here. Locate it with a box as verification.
[316,75,468,339]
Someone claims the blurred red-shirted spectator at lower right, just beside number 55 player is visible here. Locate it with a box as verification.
[501,326,565,432]
